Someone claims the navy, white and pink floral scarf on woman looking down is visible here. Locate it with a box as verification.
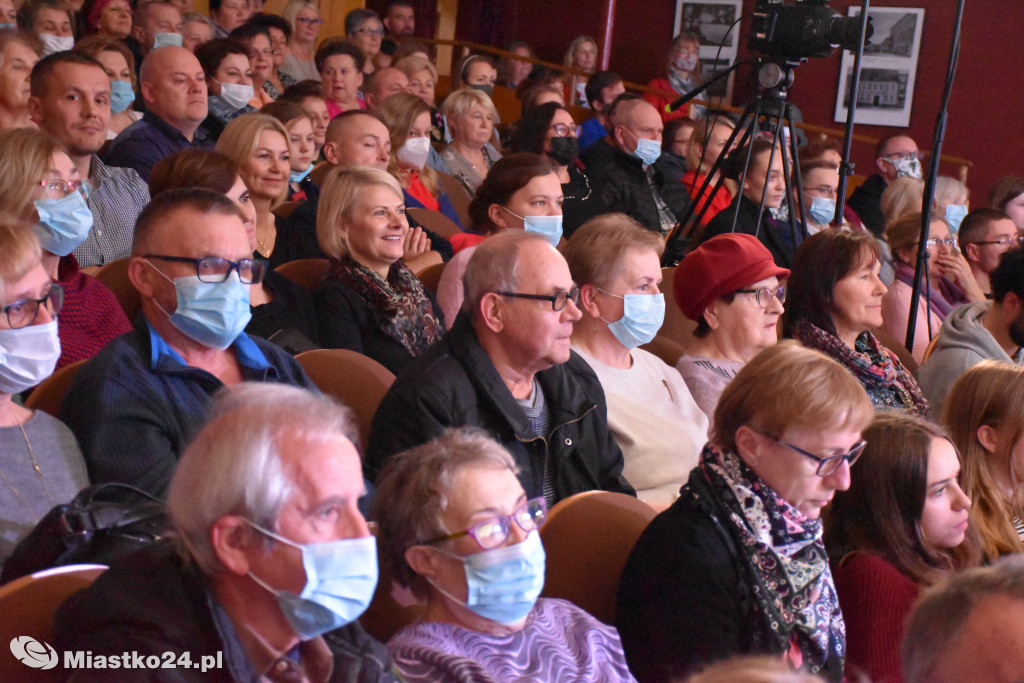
[691,443,846,675]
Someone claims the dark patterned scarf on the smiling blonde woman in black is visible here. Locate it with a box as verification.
[327,255,443,356]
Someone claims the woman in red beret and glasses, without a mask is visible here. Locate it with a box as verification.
[672,232,790,420]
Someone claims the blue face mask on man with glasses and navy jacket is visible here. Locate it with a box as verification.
[146,261,252,350]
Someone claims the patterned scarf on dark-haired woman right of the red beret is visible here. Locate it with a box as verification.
[793,321,928,415]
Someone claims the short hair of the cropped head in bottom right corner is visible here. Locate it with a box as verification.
[900,555,1024,683]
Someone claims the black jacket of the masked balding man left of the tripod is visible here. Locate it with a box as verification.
[601,148,691,232]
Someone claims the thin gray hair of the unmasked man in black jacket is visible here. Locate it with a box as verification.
[462,230,547,319]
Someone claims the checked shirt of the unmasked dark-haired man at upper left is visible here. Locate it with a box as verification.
[74,155,150,266]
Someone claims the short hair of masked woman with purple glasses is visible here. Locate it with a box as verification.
[373,428,518,599]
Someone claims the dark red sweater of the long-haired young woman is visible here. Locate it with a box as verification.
[833,552,921,683]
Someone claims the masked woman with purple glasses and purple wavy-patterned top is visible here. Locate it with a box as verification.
[375,430,634,683]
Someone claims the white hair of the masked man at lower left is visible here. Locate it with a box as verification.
[167,382,358,574]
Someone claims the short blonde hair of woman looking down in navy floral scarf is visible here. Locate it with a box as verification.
[711,340,874,451]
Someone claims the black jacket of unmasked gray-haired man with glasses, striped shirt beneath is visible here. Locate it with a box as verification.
[366,314,636,501]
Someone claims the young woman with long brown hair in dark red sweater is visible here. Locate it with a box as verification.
[824,413,981,681]
